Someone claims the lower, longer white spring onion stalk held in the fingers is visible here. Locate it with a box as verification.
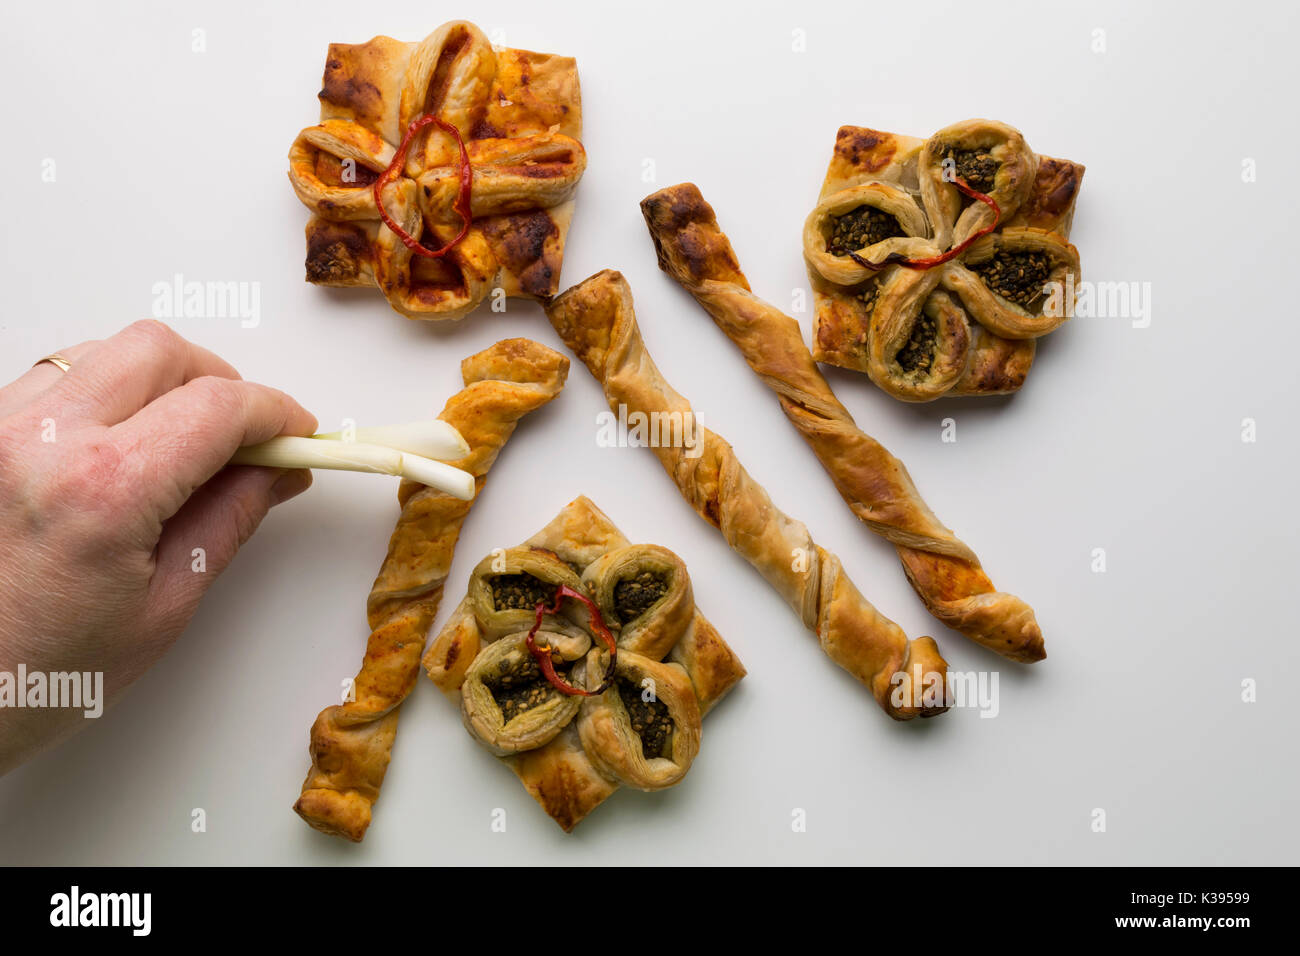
[230,436,475,501]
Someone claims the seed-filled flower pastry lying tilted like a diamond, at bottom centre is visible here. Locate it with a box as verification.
[424,498,745,831]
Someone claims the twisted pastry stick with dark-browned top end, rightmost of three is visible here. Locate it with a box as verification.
[641,183,1047,661]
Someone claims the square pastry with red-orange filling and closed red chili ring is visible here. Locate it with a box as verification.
[289,21,586,319]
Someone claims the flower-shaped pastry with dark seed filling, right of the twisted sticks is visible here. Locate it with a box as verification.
[803,120,1083,402]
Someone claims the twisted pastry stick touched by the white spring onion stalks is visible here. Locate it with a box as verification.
[294,338,569,842]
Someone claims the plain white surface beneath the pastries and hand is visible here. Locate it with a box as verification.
[0,0,1300,866]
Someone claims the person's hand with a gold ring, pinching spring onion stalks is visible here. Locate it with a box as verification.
[0,321,316,775]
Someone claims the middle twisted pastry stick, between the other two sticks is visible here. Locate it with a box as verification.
[546,269,948,721]
